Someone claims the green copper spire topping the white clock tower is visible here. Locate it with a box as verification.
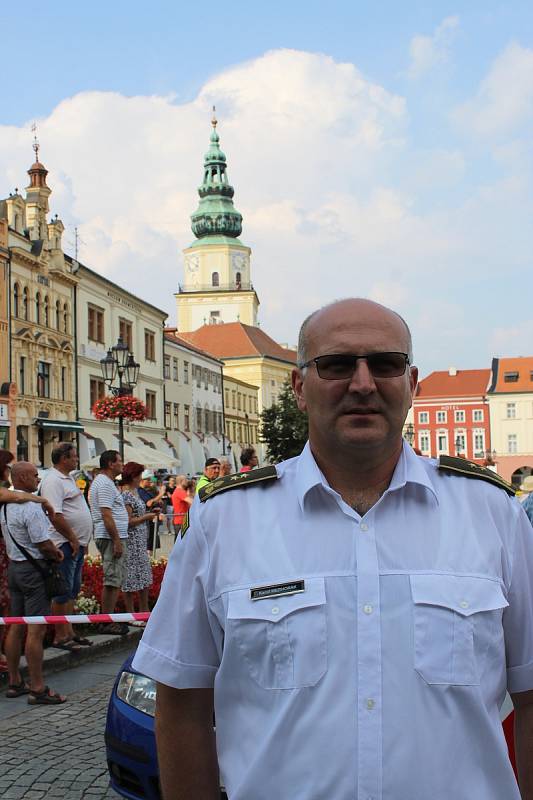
[191,106,242,239]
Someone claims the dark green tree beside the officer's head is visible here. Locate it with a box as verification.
[261,378,307,464]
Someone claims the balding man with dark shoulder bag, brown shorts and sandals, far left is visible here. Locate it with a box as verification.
[0,461,66,705]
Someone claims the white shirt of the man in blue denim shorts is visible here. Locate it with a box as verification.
[41,467,93,547]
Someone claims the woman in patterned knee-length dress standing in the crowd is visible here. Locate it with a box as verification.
[122,461,156,625]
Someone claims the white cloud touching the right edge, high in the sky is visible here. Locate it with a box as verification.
[453,42,533,137]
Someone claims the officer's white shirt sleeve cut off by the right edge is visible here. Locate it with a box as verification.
[503,507,533,694]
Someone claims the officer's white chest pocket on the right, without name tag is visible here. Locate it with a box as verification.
[410,574,509,686]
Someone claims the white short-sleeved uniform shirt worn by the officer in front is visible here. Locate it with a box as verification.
[133,445,533,800]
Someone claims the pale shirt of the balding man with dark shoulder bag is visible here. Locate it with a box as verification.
[0,501,50,561]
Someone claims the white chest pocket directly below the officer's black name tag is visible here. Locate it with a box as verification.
[226,578,327,689]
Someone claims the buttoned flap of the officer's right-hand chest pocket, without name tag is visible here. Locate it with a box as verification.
[410,574,509,617]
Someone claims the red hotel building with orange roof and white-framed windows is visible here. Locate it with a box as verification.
[413,368,491,463]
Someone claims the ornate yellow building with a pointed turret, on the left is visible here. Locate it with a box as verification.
[0,142,82,467]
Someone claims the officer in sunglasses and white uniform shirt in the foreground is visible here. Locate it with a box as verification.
[133,300,533,800]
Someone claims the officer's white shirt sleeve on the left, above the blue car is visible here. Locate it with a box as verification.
[133,502,223,689]
